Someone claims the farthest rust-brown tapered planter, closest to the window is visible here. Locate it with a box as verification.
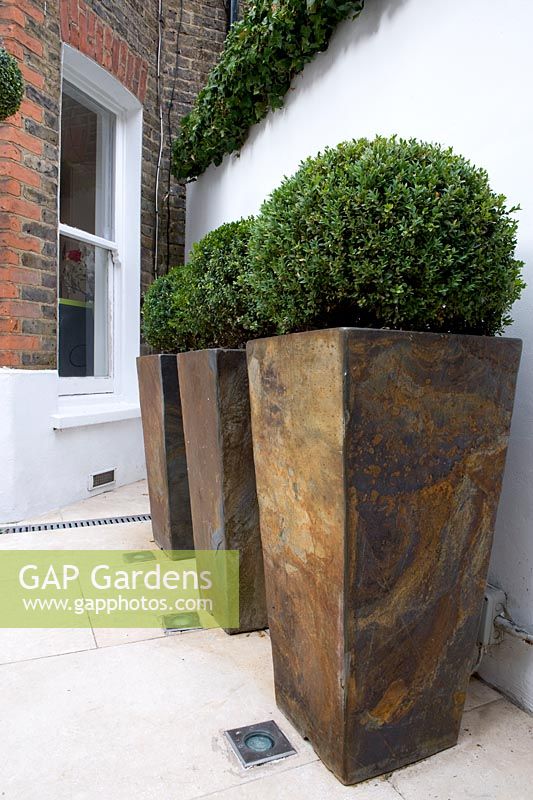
[137,355,194,550]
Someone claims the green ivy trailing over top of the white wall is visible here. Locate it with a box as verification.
[173,0,364,180]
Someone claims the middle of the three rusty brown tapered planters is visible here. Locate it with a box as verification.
[178,349,267,633]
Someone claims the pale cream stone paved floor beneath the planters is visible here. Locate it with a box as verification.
[0,482,533,800]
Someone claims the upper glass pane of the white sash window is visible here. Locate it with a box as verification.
[59,83,115,239]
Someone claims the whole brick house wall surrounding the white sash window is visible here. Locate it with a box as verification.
[0,0,226,368]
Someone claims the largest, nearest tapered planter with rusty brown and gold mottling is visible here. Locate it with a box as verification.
[248,328,521,784]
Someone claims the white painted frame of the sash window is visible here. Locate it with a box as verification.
[54,45,142,410]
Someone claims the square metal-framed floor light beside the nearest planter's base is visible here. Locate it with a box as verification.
[225,719,296,769]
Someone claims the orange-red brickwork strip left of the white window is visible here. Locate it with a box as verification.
[0,0,58,367]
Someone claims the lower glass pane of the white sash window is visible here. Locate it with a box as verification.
[59,236,111,378]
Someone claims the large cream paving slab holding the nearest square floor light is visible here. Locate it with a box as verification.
[0,631,316,800]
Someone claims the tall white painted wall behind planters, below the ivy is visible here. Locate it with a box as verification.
[187,0,533,709]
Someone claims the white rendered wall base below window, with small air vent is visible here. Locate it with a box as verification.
[0,368,146,523]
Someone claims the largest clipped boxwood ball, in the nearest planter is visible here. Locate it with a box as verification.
[249,137,524,334]
